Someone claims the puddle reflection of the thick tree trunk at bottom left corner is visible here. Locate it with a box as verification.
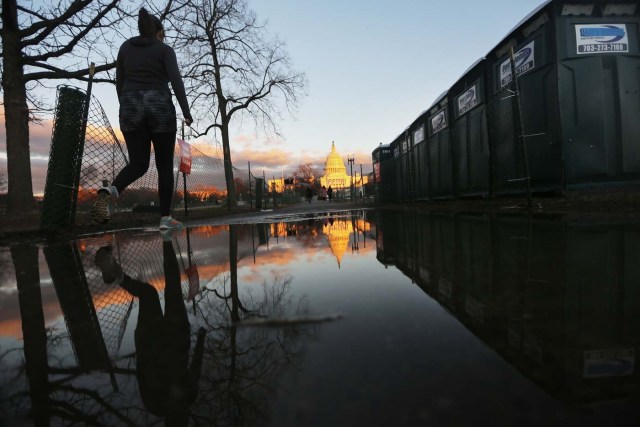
[0,244,136,426]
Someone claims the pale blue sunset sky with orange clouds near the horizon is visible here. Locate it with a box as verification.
[0,0,543,193]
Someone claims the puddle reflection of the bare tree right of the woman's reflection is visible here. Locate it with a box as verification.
[194,226,316,425]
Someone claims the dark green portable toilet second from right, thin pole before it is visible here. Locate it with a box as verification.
[486,2,562,194]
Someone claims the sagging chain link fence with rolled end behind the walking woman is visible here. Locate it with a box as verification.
[41,86,266,228]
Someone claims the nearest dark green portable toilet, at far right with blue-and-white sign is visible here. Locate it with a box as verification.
[552,0,640,187]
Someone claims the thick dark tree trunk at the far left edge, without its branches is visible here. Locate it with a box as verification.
[2,0,35,213]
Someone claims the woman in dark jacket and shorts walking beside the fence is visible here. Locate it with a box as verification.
[91,8,193,230]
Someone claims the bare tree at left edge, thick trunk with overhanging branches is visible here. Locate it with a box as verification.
[0,0,125,213]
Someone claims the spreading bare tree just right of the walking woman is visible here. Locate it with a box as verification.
[165,0,306,208]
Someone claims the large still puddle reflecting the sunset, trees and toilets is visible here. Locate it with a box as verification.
[0,211,640,426]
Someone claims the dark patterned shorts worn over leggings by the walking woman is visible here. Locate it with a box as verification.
[119,89,177,133]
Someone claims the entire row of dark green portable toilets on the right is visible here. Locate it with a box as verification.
[372,0,640,202]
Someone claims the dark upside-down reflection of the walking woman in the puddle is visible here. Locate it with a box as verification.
[95,241,205,425]
